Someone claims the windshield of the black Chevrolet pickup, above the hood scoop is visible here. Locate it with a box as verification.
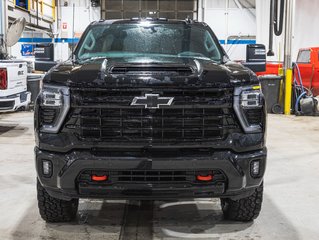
[76,22,222,62]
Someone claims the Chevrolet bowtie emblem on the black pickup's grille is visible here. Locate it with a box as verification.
[131,94,174,109]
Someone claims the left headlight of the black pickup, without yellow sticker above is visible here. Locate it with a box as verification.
[37,85,70,133]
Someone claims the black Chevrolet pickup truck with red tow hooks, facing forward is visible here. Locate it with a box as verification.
[35,18,267,222]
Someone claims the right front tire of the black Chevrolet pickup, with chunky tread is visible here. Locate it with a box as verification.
[221,184,263,222]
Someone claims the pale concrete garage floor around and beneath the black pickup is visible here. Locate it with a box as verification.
[0,112,319,240]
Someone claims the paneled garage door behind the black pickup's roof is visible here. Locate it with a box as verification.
[101,0,198,20]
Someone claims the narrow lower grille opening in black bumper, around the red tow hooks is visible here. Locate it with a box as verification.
[77,170,226,184]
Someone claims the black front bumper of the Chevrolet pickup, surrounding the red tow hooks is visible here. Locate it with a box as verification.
[35,148,267,200]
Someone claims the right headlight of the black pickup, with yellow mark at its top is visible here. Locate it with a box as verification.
[234,85,265,133]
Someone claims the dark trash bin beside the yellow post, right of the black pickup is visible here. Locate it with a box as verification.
[259,75,283,113]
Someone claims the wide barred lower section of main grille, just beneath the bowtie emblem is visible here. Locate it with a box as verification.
[80,108,223,140]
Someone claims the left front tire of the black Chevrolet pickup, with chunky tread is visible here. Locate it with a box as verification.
[37,180,79,222]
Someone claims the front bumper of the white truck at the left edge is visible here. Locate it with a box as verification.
[0,92,31,112]
